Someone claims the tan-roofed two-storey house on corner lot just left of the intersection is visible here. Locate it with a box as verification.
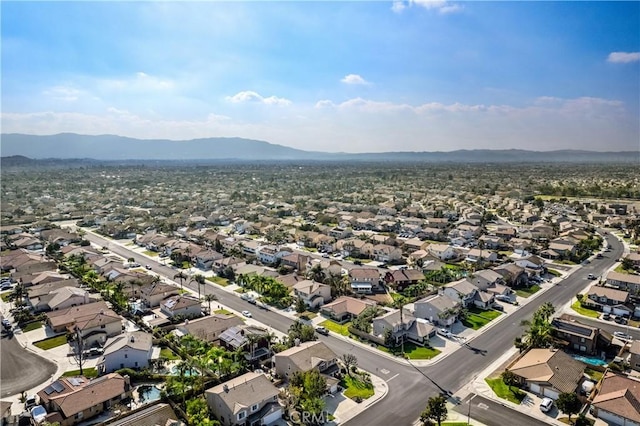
[274,340,338,384]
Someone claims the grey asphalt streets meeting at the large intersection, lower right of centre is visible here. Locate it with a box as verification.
[85,233,626,426]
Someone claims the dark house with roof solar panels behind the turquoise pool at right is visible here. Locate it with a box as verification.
[551,314,612,355]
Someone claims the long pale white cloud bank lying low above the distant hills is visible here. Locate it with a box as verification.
[0,92,639,152]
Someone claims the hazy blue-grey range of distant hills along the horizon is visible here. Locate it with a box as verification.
[0,133,640,166]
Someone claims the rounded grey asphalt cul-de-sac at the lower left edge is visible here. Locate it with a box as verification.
[0,333,57,396]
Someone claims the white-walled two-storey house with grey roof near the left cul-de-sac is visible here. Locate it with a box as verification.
[96,331,153,374]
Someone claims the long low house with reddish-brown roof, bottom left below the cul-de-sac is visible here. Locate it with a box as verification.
[38,373,131,426]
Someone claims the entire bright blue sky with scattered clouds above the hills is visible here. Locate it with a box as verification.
[0,0,640,152]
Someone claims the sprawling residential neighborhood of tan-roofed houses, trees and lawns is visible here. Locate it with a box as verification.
[0,161,640,425]
